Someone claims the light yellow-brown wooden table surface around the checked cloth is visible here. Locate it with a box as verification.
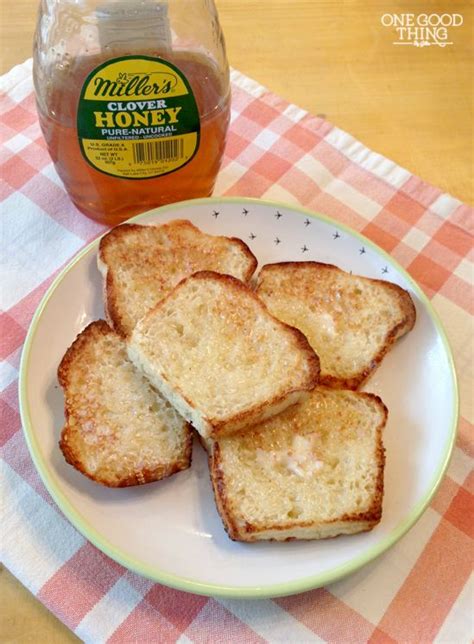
[0,0,473,643]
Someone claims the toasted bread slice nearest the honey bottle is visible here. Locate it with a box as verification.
[97,220,257,336]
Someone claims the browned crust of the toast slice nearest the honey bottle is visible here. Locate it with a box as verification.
[97,219,258,337]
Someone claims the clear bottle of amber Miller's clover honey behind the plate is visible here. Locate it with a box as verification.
[33,0,230,225]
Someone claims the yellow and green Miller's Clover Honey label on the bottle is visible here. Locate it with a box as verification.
[77,56,200,179]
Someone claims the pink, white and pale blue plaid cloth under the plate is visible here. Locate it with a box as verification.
[0,61,474,643]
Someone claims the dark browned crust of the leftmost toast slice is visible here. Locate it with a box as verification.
[57,320,192,487]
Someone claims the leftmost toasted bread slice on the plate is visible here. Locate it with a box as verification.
[58,320,192,487]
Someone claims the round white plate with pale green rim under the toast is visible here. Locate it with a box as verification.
[20,198,458,597]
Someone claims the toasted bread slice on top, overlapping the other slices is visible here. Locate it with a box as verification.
[128,271,319,438]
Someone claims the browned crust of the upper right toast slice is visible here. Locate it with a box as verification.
[255,261,416,390]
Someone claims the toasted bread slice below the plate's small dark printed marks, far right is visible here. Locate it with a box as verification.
[256,262,416,389]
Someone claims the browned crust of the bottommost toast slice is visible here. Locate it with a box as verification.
[209,392,388,542]
